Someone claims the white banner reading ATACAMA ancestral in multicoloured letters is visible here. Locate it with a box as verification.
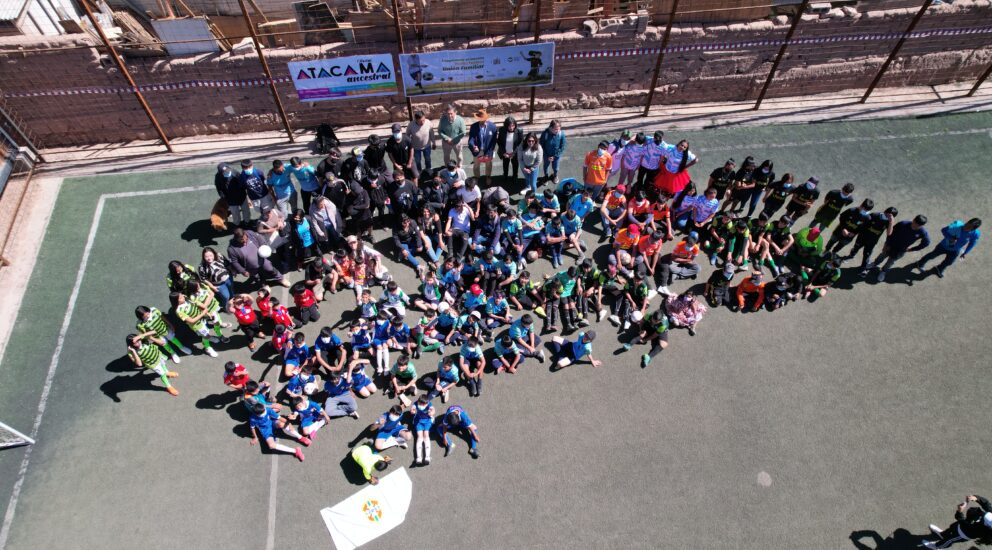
[289,54,399,101]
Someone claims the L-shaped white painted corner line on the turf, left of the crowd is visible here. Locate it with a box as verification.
[0,185,214,550]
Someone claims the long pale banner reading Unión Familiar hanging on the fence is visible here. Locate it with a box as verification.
[400,42,555,97]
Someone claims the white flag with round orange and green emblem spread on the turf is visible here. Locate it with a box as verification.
[320,468,413,550]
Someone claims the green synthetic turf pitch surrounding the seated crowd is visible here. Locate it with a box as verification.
[0,113,992,549]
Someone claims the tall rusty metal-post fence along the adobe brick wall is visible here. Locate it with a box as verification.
[0,0,992,155]
